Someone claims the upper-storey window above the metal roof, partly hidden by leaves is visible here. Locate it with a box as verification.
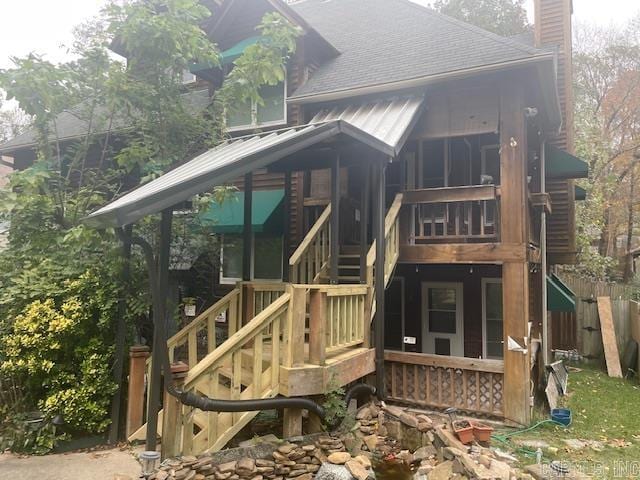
[227,82,287,130]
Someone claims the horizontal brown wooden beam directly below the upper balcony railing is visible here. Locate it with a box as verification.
[398,243,528,264]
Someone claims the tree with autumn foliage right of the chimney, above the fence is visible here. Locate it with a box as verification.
[574,21,640,280]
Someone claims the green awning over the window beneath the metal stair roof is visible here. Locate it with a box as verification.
[200,190,284,233]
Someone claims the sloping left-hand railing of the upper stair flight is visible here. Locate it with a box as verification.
[289,205,331,284]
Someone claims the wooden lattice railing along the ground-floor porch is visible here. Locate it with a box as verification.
[385,351,504,417]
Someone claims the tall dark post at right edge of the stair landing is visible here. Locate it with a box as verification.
[373,161,386,399]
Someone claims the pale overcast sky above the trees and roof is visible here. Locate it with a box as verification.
[0,0,640,68]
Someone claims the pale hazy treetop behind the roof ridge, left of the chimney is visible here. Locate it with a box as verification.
[433,0,531,37]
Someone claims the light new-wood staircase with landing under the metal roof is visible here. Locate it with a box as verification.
[129,196,402,456]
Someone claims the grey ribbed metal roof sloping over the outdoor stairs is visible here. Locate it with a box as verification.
[85,97,424,227]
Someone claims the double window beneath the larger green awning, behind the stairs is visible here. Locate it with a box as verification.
[220,233,282,283]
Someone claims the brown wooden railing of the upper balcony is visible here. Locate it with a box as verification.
[402,185,500,245]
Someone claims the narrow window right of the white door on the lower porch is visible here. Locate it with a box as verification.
[482,278,504,359]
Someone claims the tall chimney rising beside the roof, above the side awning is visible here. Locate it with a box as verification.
[534,0,574,153]
